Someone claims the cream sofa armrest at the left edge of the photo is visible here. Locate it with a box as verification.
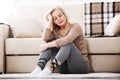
[0,24,9,72]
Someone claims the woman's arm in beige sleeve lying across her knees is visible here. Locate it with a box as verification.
[40,25,82,51]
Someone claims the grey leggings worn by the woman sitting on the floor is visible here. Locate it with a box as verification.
[38,43,89,74]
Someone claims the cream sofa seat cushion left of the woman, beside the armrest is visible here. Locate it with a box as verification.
[5,38,44,55]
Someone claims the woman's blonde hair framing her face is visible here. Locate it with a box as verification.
[45,6,68,31]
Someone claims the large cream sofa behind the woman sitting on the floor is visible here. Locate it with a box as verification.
[0,4,120,73]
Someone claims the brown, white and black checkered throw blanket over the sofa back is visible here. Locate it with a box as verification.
[84,2,120,37]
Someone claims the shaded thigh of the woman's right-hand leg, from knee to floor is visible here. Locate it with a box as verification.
[67,44,89,73]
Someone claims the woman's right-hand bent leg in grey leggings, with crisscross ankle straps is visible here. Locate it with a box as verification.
[50,43,89,73]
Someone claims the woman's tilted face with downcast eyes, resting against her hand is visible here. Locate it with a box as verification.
[52,10,67,26]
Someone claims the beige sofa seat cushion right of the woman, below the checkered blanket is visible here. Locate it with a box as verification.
[86,37,120,54]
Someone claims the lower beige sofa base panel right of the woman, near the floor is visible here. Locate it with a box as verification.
[89,55,120,72]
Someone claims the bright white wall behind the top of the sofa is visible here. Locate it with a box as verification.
[0,0,120,22]
